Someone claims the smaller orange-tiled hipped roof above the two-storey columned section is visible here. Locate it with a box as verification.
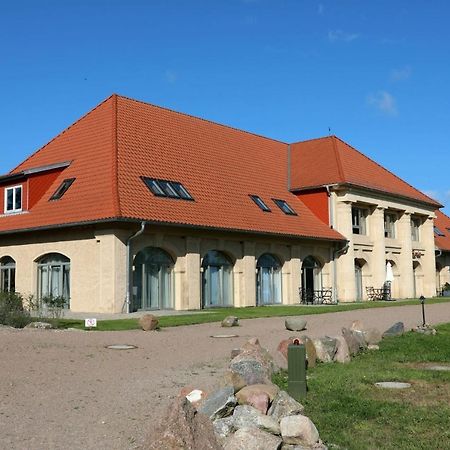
[291,136,442,207]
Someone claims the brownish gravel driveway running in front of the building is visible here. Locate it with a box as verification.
[0,303,450,450]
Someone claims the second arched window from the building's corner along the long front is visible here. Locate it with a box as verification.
[202,250,233,308]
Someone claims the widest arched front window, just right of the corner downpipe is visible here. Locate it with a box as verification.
[131,247,174,311]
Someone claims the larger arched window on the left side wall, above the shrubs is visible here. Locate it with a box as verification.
[37,253,70,308]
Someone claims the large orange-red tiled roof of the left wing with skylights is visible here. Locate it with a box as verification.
[0,95,343,240]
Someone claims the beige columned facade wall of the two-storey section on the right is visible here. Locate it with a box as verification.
[330,189,436,302]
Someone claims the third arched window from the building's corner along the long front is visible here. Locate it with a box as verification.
[256,253,281,305]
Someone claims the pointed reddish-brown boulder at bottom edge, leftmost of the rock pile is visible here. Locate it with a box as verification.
[147,397,222,450]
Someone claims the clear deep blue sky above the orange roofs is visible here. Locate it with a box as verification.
[0,0,450,214]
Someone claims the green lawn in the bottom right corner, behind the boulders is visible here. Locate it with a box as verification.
[275,324,450,450]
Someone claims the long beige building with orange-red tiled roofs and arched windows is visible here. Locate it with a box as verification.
[0,95,442,312]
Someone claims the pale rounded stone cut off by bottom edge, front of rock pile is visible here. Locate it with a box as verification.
[224,428,282,450]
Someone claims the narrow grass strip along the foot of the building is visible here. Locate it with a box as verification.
[52,297,450,331]
